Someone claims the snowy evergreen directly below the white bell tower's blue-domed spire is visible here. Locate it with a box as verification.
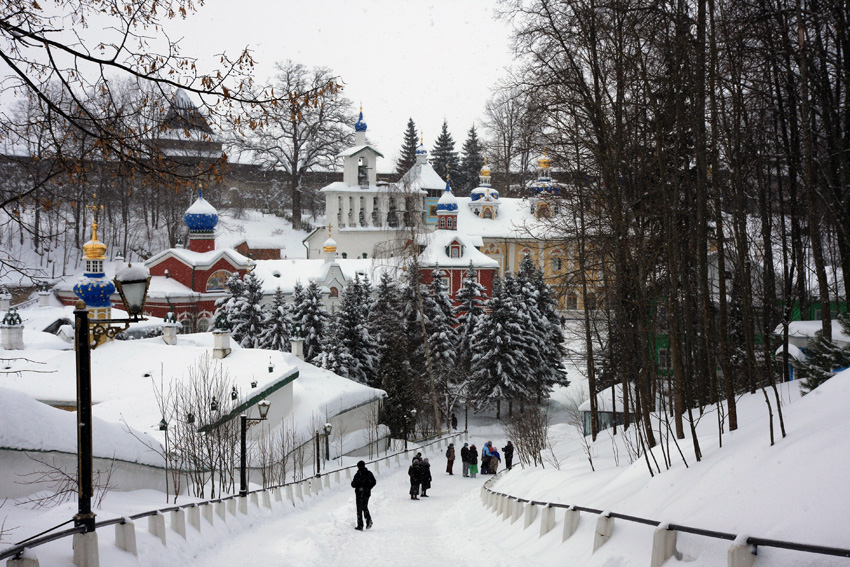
[320,276,377,384]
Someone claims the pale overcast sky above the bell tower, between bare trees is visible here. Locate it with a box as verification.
[167,0,513,172]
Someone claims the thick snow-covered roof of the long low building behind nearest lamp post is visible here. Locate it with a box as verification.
[0,307,383,460]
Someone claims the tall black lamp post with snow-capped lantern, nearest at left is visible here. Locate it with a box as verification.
[74,264,150,533]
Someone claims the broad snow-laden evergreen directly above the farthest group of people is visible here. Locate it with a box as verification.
[471,274,531,409]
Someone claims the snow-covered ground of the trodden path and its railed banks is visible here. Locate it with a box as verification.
[0,371,850,567]
